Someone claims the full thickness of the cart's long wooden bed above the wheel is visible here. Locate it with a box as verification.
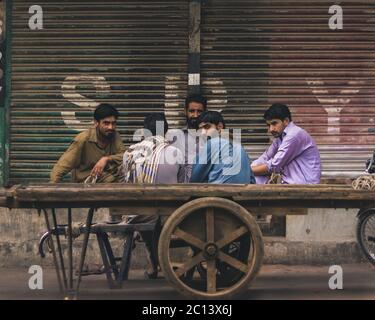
[7,184,375,210]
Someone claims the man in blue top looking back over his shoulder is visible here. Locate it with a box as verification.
[190,111,255,184]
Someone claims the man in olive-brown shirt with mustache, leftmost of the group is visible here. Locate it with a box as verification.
[50,104,125,183]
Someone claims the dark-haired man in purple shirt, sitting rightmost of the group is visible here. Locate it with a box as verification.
[251,103,321,184]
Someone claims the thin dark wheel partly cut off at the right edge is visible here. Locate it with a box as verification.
[357,209,375,265]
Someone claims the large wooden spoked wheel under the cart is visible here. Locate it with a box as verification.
[158,197,264,299]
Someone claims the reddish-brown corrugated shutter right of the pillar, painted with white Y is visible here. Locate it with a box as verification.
[201,0,375,176]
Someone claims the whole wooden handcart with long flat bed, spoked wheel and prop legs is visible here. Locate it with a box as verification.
[0,184,375,299]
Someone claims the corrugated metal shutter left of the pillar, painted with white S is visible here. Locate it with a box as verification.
[10,0,189,183]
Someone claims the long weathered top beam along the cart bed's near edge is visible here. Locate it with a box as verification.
[11,184,375,202]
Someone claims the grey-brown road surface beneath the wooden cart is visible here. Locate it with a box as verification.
[0,263,375,300]
